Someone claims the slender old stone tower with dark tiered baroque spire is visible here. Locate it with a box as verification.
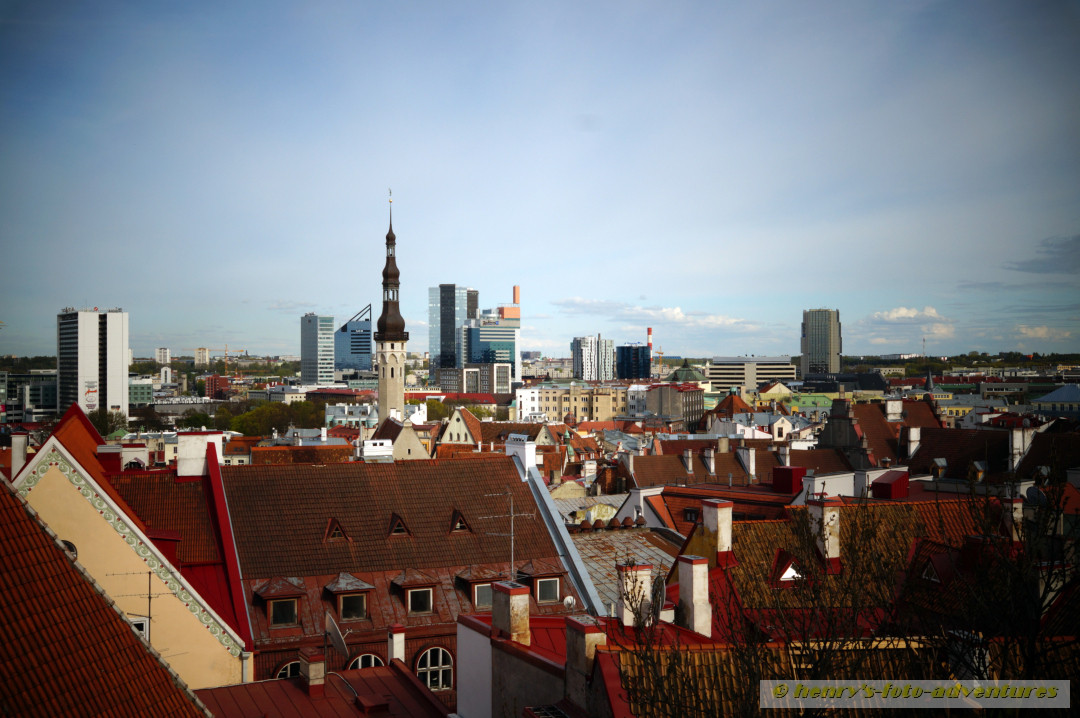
[375,200,408,425]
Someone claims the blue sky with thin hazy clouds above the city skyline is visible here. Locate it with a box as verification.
[0,0,1080,356]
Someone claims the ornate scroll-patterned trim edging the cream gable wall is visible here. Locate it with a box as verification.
[17,437,243,658]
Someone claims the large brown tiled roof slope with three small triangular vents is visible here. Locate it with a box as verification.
[221,453,557,579]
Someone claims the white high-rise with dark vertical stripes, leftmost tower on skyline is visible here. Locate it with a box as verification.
[56,307,129,417]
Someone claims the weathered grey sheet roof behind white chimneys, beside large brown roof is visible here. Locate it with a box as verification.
[570,528,679,610]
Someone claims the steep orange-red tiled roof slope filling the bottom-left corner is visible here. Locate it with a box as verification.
[0,485,206,717]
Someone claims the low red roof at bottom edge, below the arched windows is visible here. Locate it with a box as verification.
[197,661,449,718]
